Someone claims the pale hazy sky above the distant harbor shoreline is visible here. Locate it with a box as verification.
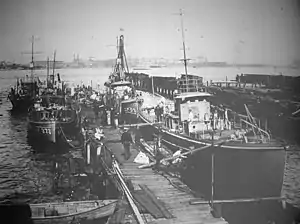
[0,0,300,65]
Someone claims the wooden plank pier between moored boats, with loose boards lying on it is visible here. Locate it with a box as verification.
[104,128,227,224]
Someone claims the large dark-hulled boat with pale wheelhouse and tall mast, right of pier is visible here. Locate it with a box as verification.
[125,9,287,200]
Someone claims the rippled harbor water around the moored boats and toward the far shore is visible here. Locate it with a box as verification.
[0,67,300,223]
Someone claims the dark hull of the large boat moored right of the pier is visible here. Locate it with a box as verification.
[124,111,286,200]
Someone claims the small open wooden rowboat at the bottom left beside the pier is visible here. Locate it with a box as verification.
[30,200,117,224]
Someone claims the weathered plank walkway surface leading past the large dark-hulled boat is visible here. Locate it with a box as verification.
[104,128,227,224]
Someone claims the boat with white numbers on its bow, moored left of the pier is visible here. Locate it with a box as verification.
[28,53,81,144]
